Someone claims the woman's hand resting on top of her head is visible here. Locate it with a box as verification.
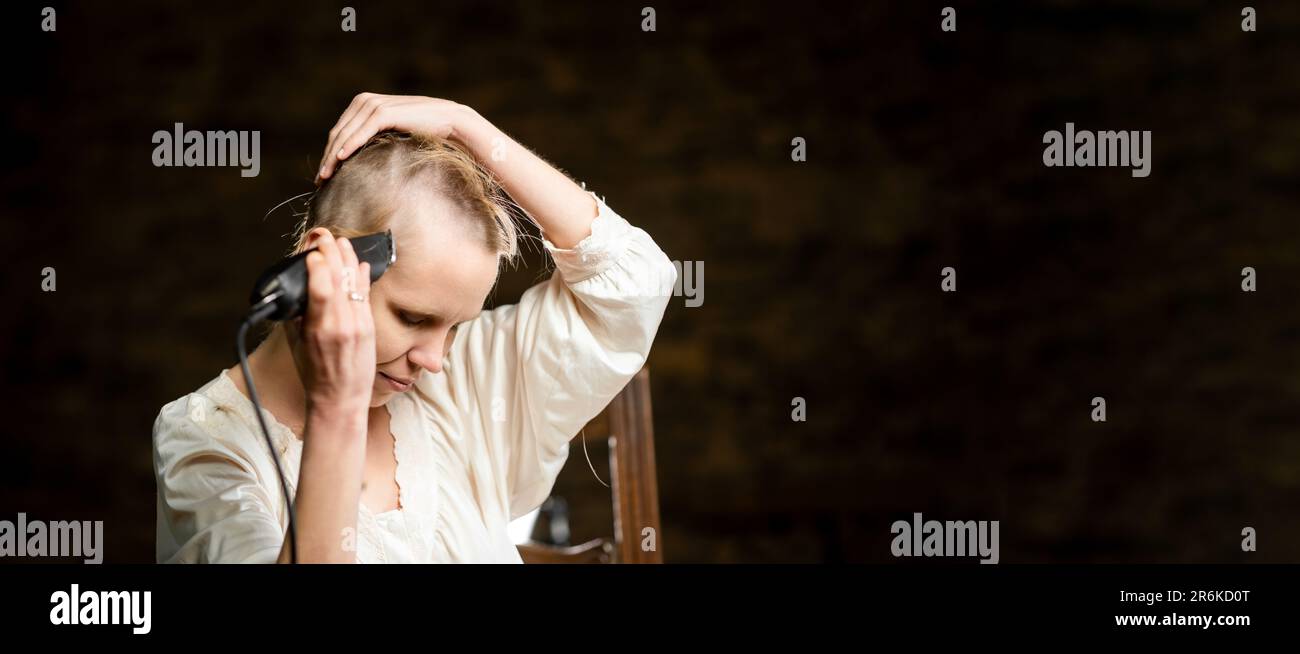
[316,92,473,183]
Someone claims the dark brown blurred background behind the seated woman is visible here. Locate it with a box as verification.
[0,0,1300,563]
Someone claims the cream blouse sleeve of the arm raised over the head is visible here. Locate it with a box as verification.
[445,194,677,520]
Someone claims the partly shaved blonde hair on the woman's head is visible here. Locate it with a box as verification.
[293,131,521,263]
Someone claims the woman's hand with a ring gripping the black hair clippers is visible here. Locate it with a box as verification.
[287,228,376,425]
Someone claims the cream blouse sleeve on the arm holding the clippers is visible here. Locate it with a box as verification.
[153,394,285,563]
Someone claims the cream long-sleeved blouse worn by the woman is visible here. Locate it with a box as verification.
[153,194,677,563]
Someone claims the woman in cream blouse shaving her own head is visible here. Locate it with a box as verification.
[153,94,676,563]
